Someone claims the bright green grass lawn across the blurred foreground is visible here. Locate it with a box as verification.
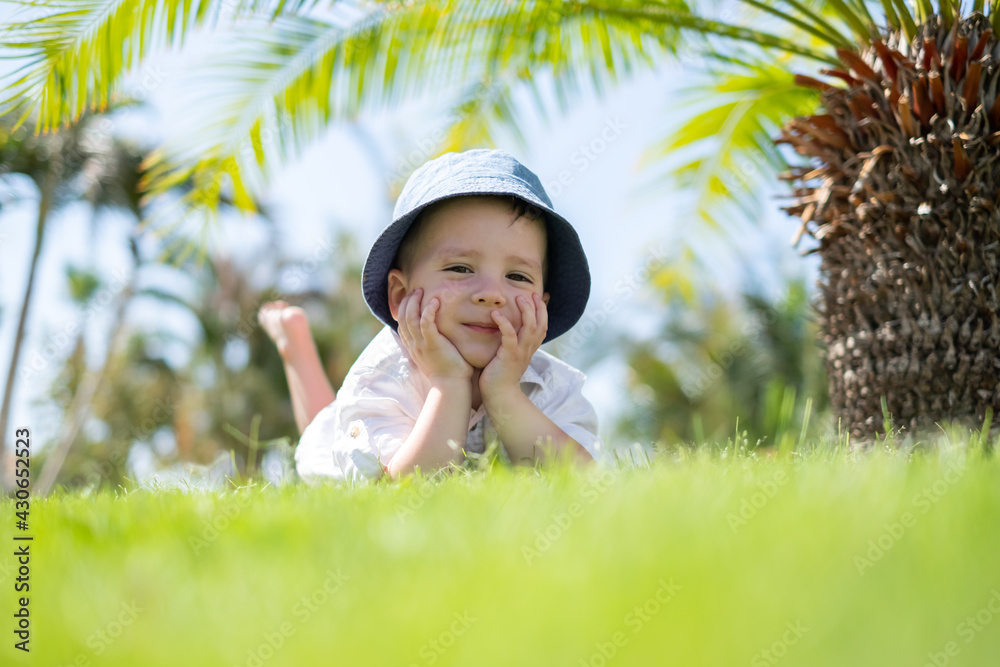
[0,436,1000,667]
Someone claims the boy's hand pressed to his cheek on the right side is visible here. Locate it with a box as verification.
[479,294,549,401]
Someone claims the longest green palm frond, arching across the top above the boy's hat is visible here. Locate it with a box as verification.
[137,0,679,224]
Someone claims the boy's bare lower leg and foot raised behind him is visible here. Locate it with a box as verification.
[257,301,336,434]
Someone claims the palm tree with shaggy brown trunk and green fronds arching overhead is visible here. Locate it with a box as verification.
[6,0,1000,436]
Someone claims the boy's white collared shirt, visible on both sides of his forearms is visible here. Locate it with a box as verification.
[295,326,615,483]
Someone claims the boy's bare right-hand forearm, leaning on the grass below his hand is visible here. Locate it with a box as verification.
[483,389,593,465]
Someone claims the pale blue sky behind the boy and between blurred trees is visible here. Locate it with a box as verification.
[0,27,815,464]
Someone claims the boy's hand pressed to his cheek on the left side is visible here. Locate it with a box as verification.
[398,289,472,380]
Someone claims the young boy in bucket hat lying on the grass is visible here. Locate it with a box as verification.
[259,149,613,482]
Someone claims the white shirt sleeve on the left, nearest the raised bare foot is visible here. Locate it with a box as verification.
[296,371,422,482]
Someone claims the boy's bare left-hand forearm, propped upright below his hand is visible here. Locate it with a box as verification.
[386,378,472,479]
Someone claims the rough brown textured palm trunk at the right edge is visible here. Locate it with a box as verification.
[779,14,1000,438]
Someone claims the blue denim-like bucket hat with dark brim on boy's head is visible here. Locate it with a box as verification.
[361,148,590,343]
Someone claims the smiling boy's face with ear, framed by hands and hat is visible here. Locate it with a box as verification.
[389,197,549,368]
